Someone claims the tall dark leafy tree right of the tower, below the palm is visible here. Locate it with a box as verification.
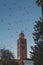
[30,20,43,65]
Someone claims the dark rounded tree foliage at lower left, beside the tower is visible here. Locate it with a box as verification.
[0,49,18,65]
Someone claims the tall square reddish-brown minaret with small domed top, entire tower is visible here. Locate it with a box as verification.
[17,32,27,59]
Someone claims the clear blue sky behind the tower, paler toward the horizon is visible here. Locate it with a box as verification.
[0,0,41,58]
